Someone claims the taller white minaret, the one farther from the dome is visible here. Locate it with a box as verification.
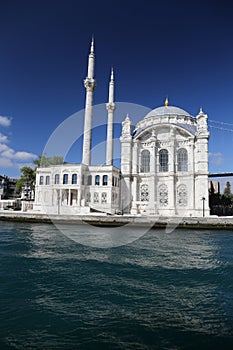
[82,37,96,165]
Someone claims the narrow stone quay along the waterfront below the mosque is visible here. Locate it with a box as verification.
[0,211,233,230]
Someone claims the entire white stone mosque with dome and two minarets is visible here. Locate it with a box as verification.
[33,40,209,217]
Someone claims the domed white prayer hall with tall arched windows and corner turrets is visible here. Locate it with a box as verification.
[121,106,209,216]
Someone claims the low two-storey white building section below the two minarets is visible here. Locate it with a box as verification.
[34,164,120,215]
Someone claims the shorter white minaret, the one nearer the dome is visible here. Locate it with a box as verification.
[106,68,116,165]
